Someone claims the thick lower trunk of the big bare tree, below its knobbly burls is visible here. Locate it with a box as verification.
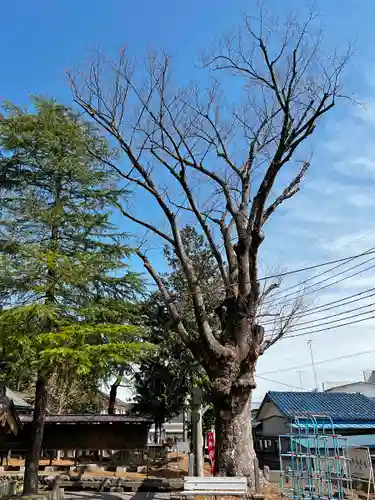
[214,388,256,485]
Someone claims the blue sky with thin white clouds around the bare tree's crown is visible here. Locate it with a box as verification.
[0,0,375,399]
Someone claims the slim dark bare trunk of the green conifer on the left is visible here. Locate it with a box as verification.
[23,374,48,495]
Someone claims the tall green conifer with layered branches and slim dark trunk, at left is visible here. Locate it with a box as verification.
[0,98,147,494]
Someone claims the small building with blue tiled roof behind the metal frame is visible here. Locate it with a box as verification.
[253,391,375,468]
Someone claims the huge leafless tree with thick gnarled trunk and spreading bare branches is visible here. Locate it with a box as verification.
[70,9,348,483]
